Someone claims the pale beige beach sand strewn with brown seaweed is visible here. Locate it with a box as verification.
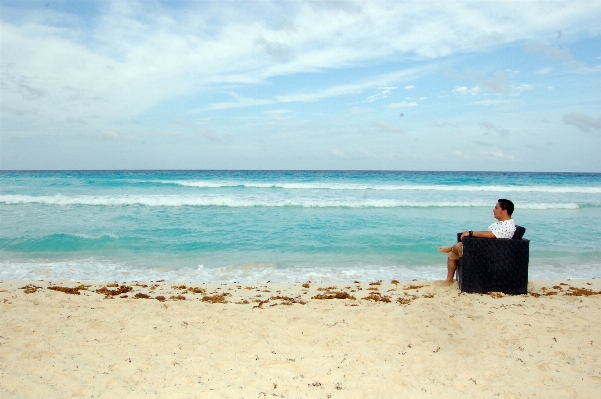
[0,279,601,398]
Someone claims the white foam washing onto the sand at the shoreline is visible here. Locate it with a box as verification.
[0,258,601,283]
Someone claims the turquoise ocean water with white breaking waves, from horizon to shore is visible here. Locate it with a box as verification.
[0,171,601,282]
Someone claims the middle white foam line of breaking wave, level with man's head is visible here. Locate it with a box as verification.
[0,194,580,210]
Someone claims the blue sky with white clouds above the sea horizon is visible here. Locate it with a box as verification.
[0,0,601,172]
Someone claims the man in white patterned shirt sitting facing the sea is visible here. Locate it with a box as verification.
[438,199,515,285]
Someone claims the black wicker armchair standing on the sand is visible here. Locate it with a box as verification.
[456,226,530,295]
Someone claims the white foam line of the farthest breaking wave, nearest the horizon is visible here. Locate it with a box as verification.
[159,180,601,194]
